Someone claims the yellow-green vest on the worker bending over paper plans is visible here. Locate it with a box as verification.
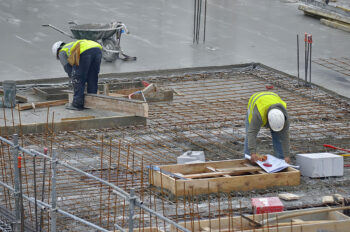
[248,92,287,126]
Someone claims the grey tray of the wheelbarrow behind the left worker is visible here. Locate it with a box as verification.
[70,24,117,41]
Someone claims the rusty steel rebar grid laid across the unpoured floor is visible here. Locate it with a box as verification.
[0,70,350,231]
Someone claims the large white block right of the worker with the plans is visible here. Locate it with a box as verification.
[296,153,344,177]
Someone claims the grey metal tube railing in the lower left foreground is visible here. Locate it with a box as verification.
[0,134,189,232]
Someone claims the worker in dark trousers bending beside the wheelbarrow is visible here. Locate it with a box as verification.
[52,40,102,110]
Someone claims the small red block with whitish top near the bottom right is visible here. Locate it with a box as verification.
[252,197,284,214]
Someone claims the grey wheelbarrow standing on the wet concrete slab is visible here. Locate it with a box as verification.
[42,22,136,62]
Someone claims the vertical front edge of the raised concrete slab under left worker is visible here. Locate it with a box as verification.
[0,116,147,136]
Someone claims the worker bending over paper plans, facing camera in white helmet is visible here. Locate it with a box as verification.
[244,92,290,163]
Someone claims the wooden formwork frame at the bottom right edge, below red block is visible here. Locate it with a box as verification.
[171,209,350,232]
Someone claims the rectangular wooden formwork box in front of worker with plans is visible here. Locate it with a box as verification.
[149,159,300,196]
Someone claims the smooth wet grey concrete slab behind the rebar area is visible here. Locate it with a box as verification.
[0,0,350,97]
